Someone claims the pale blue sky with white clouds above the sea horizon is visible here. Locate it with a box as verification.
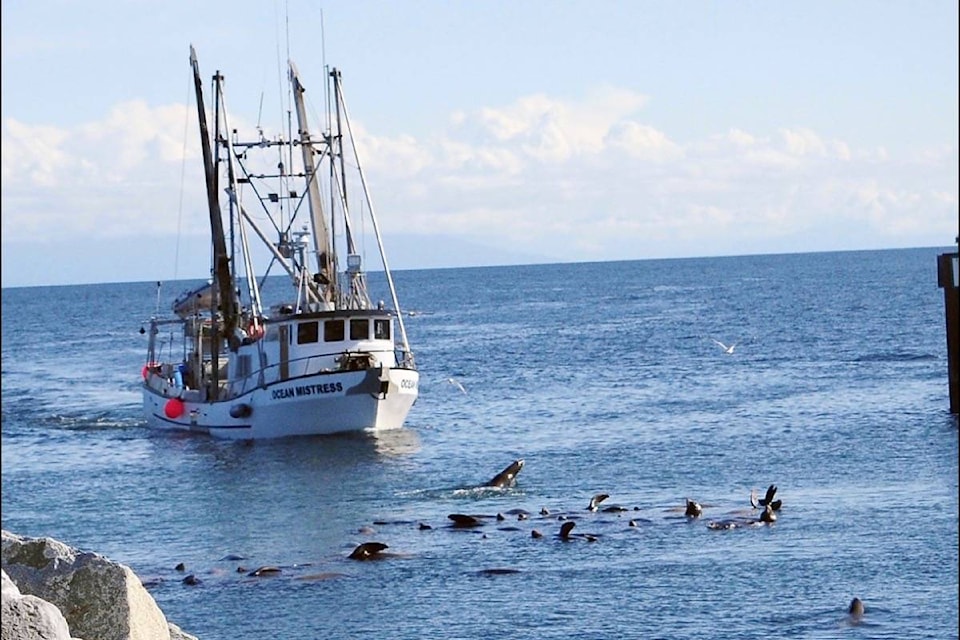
[0,0,960,287]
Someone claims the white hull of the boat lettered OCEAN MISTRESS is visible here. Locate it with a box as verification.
[143,368,420,440]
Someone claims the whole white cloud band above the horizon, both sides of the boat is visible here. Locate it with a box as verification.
[2,88,958,284]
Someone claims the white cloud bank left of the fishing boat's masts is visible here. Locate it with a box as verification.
[2,102,205,241]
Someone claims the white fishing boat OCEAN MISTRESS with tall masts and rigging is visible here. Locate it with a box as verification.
[141,46,419,439]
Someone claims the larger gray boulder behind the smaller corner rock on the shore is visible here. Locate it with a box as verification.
[2,531,195,640]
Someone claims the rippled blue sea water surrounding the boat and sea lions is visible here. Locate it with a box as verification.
[2,249,958,640]
